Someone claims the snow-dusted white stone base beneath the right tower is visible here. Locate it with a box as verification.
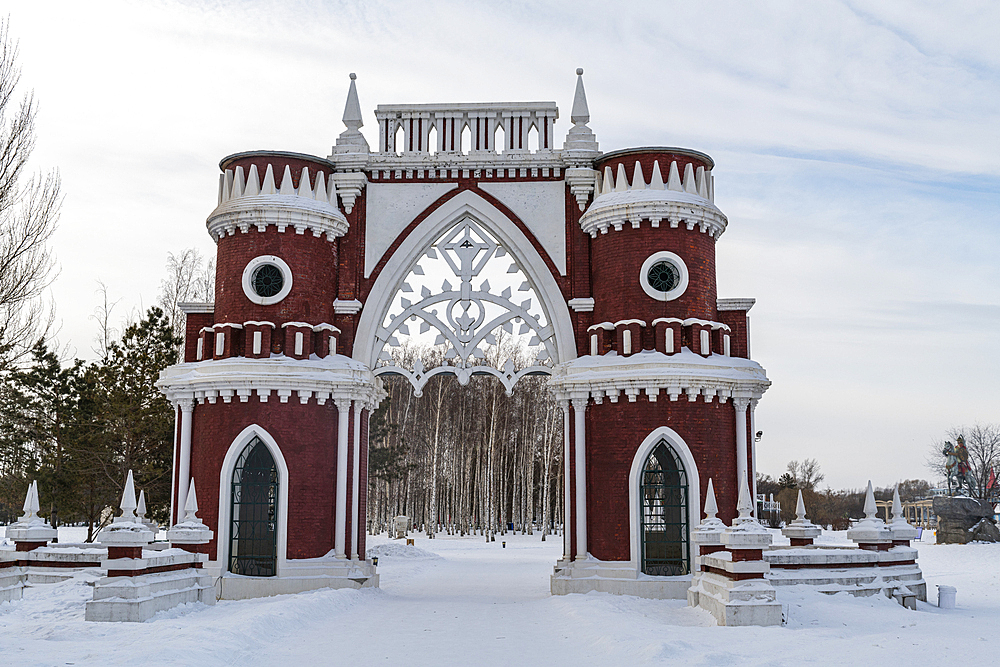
[549,557,691,600]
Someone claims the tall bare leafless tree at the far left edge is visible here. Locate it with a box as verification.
[0,20,62,368]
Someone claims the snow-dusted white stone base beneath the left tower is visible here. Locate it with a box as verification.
[206,558,379,600]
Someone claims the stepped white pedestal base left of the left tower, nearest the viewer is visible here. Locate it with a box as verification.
[84,568,215,623]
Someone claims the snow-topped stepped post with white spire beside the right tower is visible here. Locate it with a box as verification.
[688,474,781,625]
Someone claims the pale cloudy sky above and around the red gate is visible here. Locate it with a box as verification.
[7,0,1000,488]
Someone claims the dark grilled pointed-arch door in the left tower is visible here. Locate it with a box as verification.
[229,436,278,577]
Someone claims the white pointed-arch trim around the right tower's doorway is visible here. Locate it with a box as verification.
[628,426,701,576]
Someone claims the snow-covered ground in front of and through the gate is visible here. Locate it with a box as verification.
[0,529,1000,667]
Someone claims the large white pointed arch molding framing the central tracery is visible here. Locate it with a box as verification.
[354,190,576,368]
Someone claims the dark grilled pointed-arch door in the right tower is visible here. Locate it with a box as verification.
[639,440,691,576]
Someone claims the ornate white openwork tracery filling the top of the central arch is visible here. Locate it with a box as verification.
[375,215,557,396]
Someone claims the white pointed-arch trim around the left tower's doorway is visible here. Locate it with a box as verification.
[215,424,288,577]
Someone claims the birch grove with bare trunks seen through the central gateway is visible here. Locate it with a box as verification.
[368,349,563,540]
